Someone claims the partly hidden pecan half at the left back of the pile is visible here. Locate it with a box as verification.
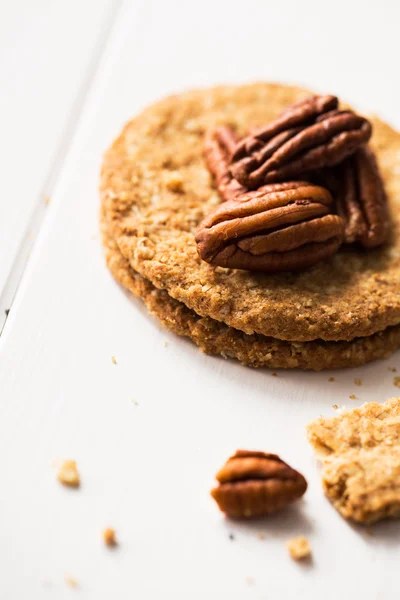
[204,126,246,200]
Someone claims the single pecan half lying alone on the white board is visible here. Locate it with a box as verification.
[211,450,307,518]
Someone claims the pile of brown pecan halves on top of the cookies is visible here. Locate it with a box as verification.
[195,96,390,273]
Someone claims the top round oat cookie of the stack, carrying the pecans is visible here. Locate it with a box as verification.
[101,84,400,342]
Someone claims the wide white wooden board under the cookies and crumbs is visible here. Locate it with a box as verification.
[0,0,400,600]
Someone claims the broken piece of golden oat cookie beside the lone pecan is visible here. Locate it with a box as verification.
[308,398,400,523]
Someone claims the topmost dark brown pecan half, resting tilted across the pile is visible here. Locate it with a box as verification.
[231,96,372,189]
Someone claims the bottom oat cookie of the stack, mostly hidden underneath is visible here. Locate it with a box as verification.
[101,214,400,371]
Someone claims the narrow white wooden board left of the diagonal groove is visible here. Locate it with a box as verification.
[0,0,120,329]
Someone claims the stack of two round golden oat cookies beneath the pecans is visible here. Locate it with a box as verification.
[101,84,400,370]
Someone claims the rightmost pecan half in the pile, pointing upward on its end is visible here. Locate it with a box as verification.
[337,146,390,248]
